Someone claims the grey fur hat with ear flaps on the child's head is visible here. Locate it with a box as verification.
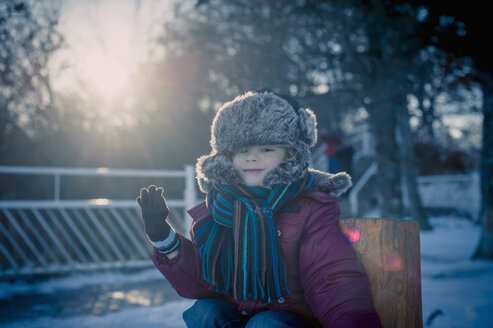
[196,89,351,196]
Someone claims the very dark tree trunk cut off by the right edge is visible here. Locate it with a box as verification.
[473,74,493,259]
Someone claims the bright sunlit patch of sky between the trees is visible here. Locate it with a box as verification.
[52,0,178,102]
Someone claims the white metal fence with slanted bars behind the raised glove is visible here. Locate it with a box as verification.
[0,166,197,277]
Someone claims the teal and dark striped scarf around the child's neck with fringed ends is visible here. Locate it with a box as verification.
[193,174,314,303]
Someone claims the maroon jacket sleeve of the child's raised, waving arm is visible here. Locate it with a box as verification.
[152,233,219,299]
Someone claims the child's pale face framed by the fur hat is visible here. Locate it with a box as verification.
[233,145,286,187]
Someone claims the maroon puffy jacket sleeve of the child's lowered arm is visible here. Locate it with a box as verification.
[299,197,381,328]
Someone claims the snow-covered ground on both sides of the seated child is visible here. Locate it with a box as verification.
[0,216,493,328]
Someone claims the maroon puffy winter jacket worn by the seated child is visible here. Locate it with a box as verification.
[152,192,381,328]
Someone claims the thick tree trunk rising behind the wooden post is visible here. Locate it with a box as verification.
[362,1,407,219]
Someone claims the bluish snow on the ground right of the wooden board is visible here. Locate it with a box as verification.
[420,217,493,327]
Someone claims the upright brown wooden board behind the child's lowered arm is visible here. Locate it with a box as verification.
[339,218,423,328]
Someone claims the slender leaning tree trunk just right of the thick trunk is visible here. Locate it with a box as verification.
[396,107,431,230]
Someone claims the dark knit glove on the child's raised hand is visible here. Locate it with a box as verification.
[137,185,171,242]
